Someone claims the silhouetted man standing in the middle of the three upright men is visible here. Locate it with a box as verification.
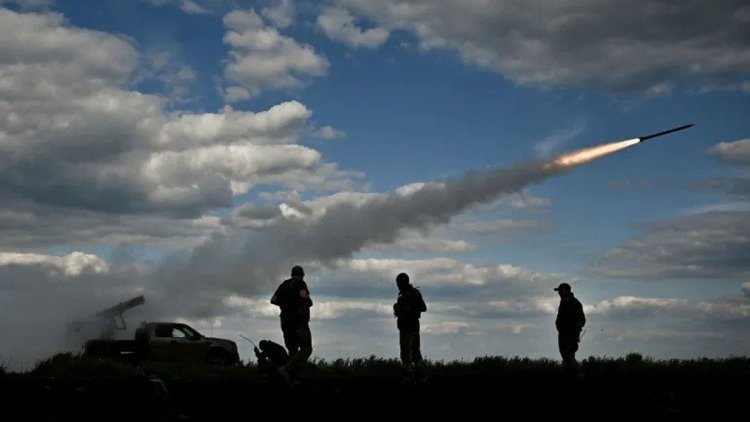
[393,273,427,379]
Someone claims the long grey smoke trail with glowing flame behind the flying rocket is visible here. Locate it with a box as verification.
[161,138,638,313]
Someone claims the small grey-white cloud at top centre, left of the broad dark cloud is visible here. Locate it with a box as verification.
[318,7,389,49]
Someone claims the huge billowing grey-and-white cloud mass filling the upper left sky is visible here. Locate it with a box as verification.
[0,9,349,221]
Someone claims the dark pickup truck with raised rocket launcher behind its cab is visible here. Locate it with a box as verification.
[83,322,240,365]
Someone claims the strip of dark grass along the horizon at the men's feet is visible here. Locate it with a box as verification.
[16,353,750,380]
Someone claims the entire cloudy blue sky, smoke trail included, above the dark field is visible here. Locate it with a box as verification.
[0,0,750,370]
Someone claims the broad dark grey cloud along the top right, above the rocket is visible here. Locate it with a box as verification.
[336,0,750,95]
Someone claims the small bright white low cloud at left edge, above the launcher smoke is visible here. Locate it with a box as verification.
[0,252,109,277]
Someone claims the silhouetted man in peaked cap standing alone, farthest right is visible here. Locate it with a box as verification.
[555,283,586,376]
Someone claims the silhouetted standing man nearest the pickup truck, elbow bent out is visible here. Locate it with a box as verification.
[271,265,312,383]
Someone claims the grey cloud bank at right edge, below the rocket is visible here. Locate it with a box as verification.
[594,211,750,280]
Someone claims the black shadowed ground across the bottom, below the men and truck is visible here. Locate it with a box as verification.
[0,356,750,421]
